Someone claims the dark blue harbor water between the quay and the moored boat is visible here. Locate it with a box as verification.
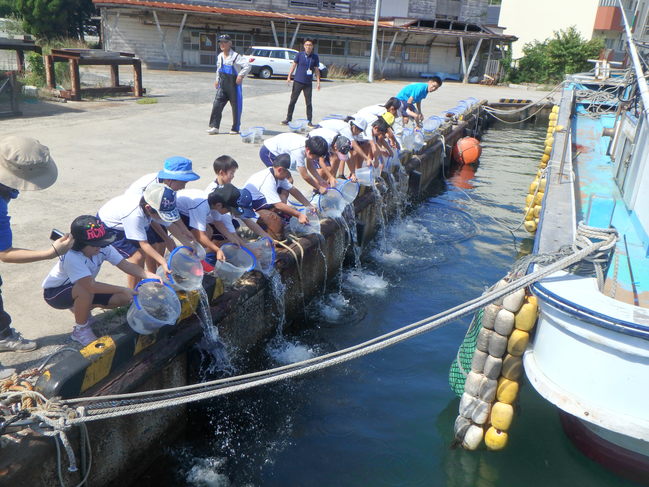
[136,125,632,487]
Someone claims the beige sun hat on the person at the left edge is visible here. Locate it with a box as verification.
[0,135,58,191]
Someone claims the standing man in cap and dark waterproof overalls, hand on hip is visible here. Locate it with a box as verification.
[207,34,250,135]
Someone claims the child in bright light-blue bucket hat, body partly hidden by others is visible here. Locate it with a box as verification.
[126,156,200,272]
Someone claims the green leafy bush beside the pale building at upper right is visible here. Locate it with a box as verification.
[508,26,604,83]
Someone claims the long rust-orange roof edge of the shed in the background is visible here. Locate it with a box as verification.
[93,0,393,28]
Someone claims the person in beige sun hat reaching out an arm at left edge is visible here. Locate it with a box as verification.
[0,136,72,377]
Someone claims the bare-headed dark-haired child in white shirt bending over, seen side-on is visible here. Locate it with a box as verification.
[259,133,336,193]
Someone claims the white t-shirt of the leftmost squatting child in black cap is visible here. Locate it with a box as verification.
[42,245,124,289]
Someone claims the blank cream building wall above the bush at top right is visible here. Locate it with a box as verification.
[499,0,598,59]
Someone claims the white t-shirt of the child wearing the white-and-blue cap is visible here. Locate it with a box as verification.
[98,193,151,242]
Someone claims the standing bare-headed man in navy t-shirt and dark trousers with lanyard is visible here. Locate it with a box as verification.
[282,39,320,127]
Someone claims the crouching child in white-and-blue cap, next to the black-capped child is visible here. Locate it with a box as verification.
[98,183,192,288]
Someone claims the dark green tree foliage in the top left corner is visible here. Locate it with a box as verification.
[12,0,94,39]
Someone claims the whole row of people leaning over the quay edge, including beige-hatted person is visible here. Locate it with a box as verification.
[0,78,442,366]
